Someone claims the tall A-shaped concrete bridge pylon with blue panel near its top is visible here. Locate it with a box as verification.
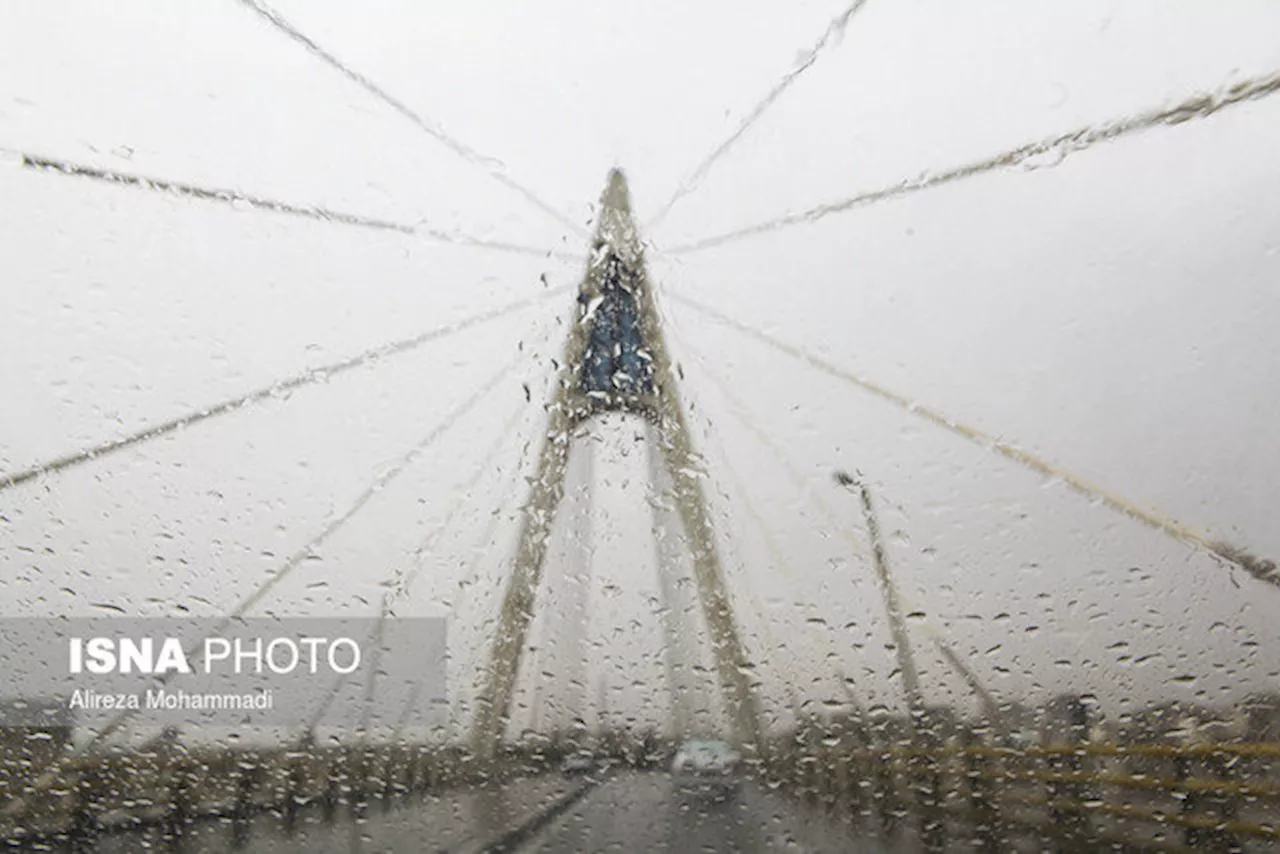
[471,169,760,759]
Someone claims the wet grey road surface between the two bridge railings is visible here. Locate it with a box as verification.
[81,771,919,854]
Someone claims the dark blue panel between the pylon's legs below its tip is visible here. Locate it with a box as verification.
[580,254,653,402]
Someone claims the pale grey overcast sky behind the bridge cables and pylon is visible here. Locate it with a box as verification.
[0,0,1280,737]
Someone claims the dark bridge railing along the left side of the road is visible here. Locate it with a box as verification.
[0,730,675,845]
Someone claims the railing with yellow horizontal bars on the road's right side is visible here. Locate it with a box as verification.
[764,741,1280,850]
